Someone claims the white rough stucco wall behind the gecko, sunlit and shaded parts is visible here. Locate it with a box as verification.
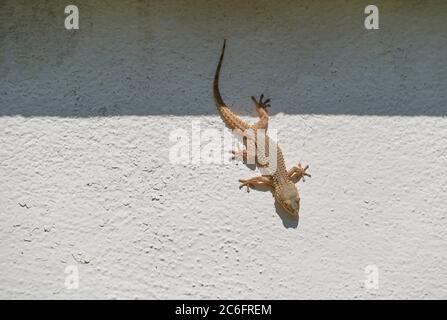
[0,0,447,298]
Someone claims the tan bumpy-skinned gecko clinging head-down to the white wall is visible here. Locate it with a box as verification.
[213,40,311,217]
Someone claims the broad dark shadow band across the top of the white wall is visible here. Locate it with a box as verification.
[0,0,447,117]
